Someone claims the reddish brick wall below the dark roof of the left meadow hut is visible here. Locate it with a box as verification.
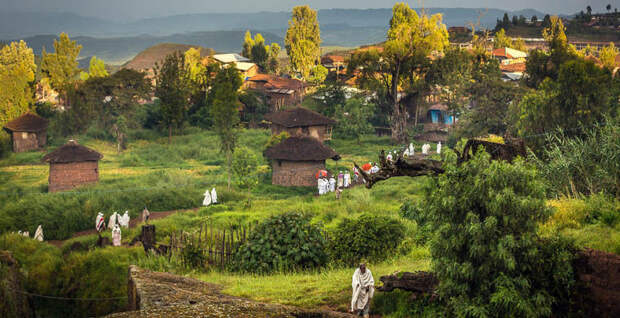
[48,161,99,192]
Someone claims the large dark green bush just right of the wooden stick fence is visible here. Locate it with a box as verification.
[234,212,327,273]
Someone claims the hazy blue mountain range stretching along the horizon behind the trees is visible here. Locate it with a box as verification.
[0,8,544,64]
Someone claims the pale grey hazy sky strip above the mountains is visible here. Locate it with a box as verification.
[0,0,620,20]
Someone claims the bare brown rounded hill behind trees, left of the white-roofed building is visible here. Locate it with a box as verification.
[123,43,214,71]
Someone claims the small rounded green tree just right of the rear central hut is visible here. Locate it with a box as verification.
[335,98,375,143]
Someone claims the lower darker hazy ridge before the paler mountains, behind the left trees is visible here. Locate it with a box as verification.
[16,31,284,65]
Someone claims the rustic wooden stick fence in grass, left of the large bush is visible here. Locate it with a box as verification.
[169,223,255,268]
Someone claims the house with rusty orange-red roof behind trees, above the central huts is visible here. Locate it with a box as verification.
[244,74,305,111]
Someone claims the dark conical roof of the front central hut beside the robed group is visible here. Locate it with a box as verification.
[265,137,340,161]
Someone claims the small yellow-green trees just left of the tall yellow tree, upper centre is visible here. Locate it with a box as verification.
[241,30,281,73]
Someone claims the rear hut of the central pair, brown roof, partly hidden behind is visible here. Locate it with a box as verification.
[265,107,336,142]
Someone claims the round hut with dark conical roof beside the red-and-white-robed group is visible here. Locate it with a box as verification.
[264,137,340,187]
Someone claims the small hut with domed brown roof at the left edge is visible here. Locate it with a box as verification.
[4,113,49,152]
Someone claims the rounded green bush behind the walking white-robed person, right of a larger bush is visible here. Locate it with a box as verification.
[329,214,405,265]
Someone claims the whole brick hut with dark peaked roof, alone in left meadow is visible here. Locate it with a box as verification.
[42,140,103,192]
